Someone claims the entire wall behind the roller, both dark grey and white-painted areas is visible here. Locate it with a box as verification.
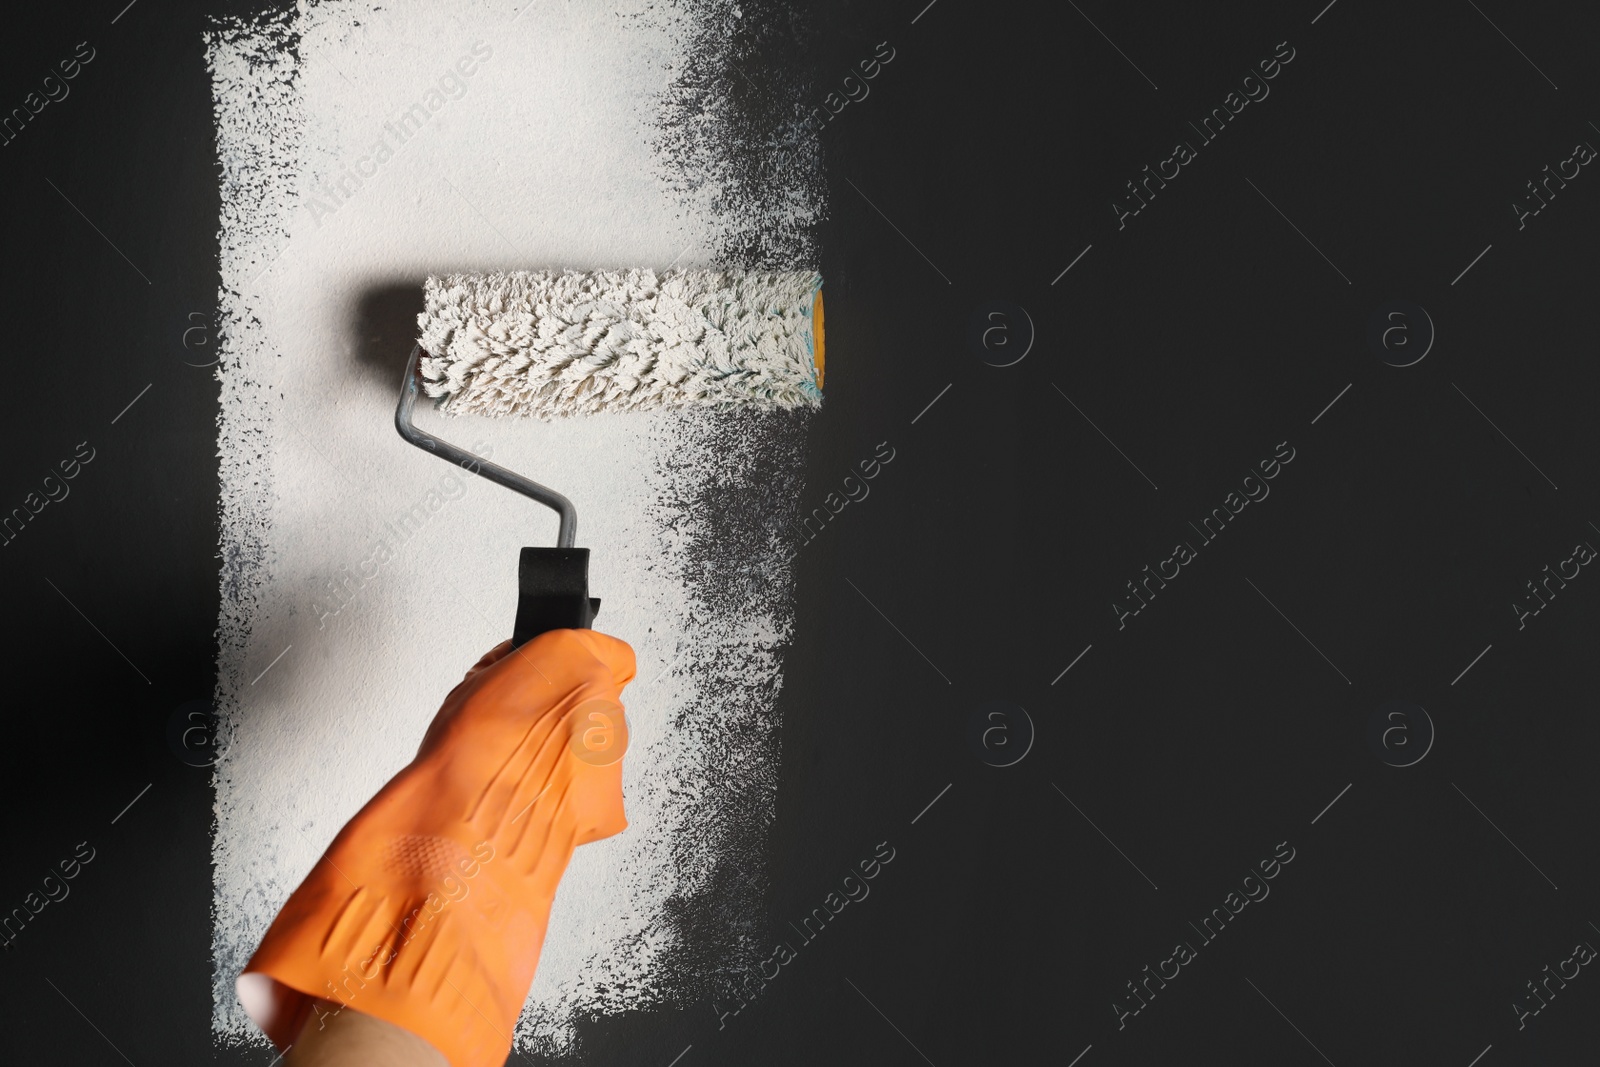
[0,0,1600,1067]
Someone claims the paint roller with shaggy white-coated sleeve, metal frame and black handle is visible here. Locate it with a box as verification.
[395,270,824,648]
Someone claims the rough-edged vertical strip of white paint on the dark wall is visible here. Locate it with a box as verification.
[211,3,821,1051]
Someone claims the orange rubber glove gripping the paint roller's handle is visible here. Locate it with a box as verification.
[237,630,635,1067]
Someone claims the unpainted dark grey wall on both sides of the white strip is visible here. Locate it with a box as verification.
[0,0,1600,1067]
